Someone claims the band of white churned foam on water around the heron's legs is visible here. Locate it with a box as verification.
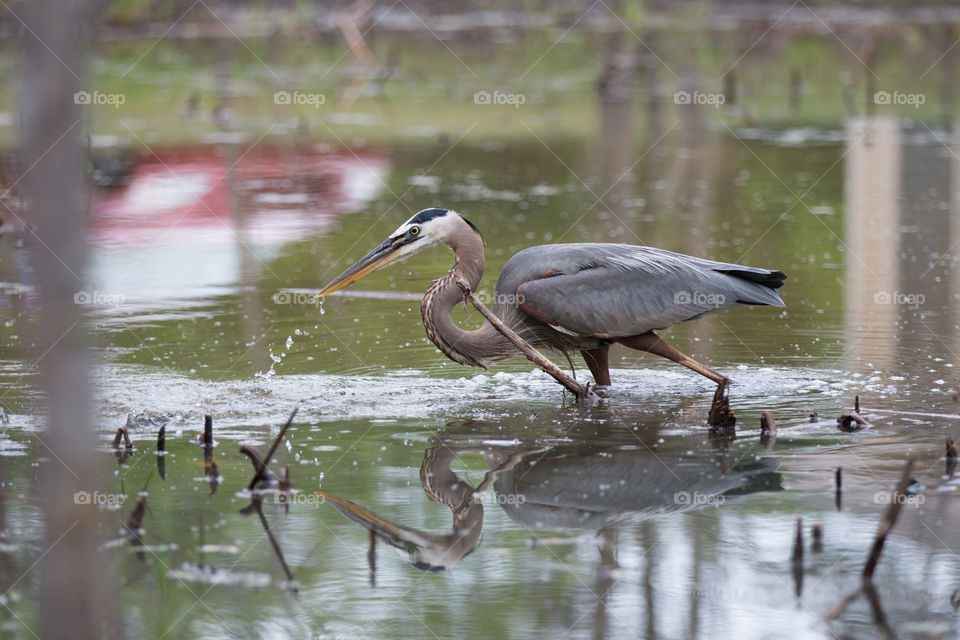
[80,365,872,432]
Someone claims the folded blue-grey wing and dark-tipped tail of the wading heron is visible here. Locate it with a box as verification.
[497,243,786,338]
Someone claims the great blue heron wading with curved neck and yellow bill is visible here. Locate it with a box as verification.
[317,209,786,387]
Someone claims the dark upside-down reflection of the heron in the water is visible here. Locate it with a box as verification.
[322,425,780,571]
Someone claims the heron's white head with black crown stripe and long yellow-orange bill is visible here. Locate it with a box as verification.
[317,209,480,297]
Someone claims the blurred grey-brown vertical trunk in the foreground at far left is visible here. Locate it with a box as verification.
[21,0,104,638]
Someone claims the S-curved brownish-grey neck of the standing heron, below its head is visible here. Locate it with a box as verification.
[420,232,517,369]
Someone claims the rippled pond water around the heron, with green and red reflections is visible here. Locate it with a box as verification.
[0,13,960,638]
